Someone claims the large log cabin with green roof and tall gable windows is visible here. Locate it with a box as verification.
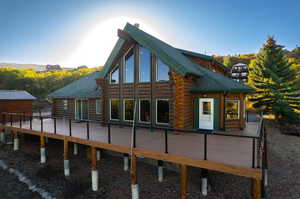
[49,23,253,130]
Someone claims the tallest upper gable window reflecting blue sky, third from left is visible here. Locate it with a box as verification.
[140,47,151,82]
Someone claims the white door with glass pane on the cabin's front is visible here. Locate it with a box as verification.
[199,98,214,130]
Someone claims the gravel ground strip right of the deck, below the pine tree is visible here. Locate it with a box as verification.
[267,121,300,199]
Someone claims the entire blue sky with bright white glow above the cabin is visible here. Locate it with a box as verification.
[0,0,300,67]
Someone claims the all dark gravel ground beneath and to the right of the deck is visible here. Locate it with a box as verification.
[0,119,300,199]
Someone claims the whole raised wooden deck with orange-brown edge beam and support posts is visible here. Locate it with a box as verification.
[0,117,267,199]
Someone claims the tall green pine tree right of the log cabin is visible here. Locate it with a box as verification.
[249,37,300,121]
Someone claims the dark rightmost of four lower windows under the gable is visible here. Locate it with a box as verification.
[156,99,170,124]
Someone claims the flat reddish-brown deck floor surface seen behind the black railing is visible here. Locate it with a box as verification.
[7,119,258,168]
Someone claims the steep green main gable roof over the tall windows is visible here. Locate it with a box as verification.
[104,23,203,77]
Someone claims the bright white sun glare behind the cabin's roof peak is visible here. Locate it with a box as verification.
[62,17,160,67]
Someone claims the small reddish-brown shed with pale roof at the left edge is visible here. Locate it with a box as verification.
[0,90,36,123]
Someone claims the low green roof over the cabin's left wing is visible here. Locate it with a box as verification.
[48,71,104,98]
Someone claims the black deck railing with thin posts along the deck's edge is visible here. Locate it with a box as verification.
[1,113,267,168]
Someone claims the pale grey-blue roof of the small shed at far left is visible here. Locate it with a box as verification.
[0,90,36,100]
